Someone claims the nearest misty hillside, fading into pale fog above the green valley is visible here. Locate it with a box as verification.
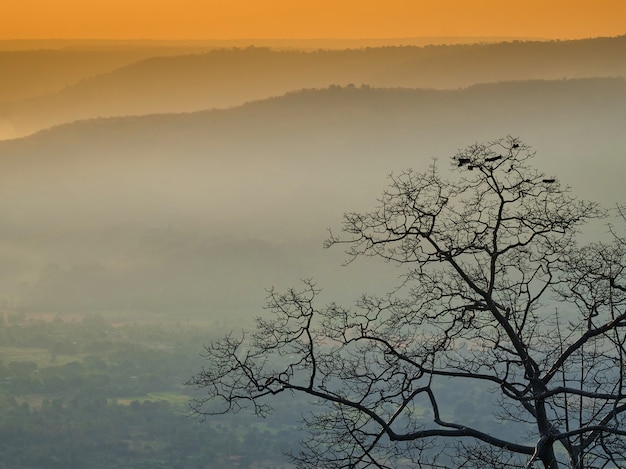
[0,79,626,312]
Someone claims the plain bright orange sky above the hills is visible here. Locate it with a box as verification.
[0,0,626,39]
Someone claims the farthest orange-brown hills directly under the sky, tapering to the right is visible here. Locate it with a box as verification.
[0,37,529,103]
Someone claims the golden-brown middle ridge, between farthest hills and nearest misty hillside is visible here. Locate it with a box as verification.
[0,36,626,137]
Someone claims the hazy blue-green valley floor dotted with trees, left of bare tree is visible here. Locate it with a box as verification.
[0,314,300,469]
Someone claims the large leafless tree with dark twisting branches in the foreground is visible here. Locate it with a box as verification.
[190,137,626,469]
